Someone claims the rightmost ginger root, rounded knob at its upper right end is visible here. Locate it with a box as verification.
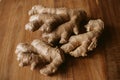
[61,19,104,57]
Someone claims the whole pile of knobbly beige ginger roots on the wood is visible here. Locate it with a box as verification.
[15,5,104,75]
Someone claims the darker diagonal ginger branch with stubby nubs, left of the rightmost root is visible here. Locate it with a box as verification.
[42,11,86,44]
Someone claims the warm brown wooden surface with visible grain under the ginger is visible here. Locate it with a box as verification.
[0,0,120,80]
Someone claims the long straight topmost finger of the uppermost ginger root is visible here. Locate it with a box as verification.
[28,5,81,16]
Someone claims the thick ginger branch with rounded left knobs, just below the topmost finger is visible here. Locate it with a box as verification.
[25,14,69,32]
